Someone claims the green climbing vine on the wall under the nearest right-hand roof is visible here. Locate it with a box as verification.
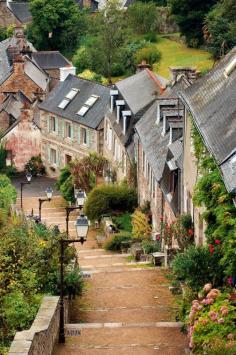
[191,122,236,276]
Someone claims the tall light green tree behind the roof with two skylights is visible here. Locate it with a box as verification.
[85,0,128,82]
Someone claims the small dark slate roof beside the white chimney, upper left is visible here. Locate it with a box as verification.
[32,51,71,70]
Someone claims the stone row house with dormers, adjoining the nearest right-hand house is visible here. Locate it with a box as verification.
[135,78,188,234]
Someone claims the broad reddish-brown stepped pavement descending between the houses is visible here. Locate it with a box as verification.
[14,194,187,355]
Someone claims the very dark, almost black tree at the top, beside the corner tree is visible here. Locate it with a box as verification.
[169,0,217,47]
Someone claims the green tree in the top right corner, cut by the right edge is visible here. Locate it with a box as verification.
[204,0,236,59]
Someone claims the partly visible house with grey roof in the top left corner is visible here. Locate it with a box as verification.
[0,0,32,27]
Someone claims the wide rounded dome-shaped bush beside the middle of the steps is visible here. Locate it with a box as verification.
[85,185,137,221]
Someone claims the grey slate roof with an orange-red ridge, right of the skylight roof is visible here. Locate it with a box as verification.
[116,69,167,115]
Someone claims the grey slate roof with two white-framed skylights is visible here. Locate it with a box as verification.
[39,74,110,129]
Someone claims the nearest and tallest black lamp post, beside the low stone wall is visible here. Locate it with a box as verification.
[59,214,89,344]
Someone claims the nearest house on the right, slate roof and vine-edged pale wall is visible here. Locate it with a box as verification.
[179,47,236,244]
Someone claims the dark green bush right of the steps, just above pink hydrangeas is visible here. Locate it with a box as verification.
[173,246,224,291]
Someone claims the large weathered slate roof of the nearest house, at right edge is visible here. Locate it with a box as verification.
[180,47,236,195]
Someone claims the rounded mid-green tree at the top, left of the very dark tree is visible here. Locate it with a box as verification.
[127,1,160,34]
